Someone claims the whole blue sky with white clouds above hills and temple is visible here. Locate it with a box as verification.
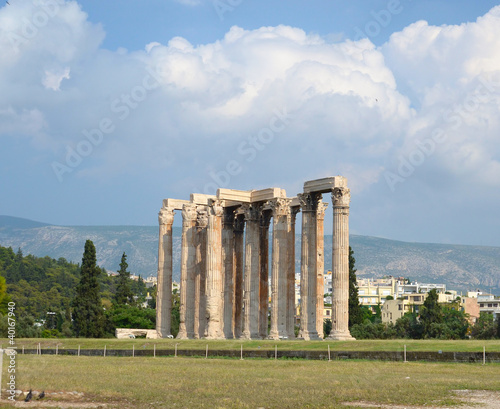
[0,0,500,246]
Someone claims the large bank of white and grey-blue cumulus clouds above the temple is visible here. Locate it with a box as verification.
[0,0,500,242]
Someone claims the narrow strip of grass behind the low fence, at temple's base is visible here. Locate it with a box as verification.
[0,338,500,352]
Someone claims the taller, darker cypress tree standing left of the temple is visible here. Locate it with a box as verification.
[72,240,105,338]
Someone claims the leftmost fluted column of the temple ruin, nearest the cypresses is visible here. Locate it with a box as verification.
[156,208,175,338]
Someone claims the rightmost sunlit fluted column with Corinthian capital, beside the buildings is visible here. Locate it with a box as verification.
[328,187,354,340]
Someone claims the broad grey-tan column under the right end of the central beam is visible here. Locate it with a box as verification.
[269,198,291,339]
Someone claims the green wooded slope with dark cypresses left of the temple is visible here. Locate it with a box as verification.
[0,240,161,338]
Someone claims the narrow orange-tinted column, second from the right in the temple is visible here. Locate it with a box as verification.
[316,202,328,338]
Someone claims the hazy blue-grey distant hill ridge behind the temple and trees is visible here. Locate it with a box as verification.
[0,216,500,293]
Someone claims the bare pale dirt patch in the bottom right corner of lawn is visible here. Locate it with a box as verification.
[344,390,500,409]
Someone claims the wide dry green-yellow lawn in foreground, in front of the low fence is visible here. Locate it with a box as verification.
[3,352,500,409]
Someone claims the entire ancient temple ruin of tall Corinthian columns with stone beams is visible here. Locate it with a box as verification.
[156,176,353,340]
